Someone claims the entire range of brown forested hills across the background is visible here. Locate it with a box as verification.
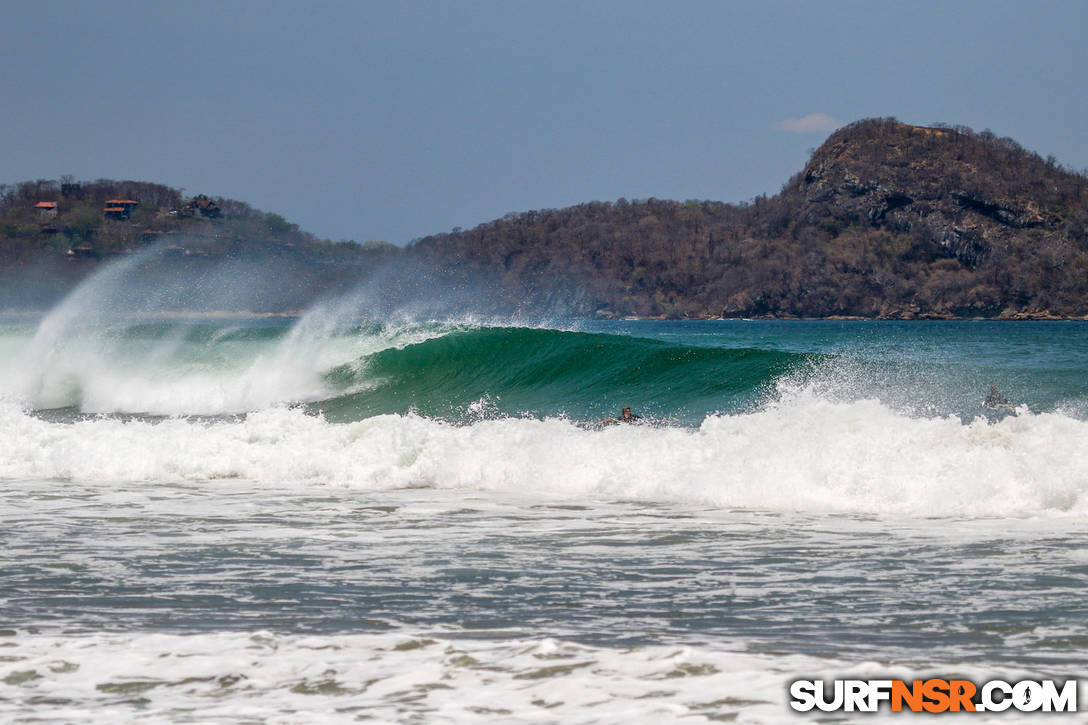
[6,119,1088,319]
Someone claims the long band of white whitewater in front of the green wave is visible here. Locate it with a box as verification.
[0,394,1088,517]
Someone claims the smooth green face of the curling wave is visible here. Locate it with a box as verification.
[312,328,813,423]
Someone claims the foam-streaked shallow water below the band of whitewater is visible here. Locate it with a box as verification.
[0,479,1088,723]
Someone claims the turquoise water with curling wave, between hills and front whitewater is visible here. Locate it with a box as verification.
[0,318,1088,426]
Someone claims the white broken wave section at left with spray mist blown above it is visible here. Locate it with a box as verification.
[0,248,507,415]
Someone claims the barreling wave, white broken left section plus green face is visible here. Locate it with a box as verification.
[0,318,813,425]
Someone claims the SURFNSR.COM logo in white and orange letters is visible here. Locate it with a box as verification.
[790,678,1077,713]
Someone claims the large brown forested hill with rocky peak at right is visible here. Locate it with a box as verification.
[409,119,1088,319]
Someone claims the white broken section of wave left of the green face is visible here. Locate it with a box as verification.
[0,322,437,416]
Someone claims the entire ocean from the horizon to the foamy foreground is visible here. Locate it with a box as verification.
[0,267,1088,723]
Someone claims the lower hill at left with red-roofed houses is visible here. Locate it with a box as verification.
[0,177,399,311]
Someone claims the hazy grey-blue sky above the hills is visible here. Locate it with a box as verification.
[0,0,1088,244]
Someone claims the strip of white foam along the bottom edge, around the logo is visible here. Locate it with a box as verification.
[6,632,1079,723]
